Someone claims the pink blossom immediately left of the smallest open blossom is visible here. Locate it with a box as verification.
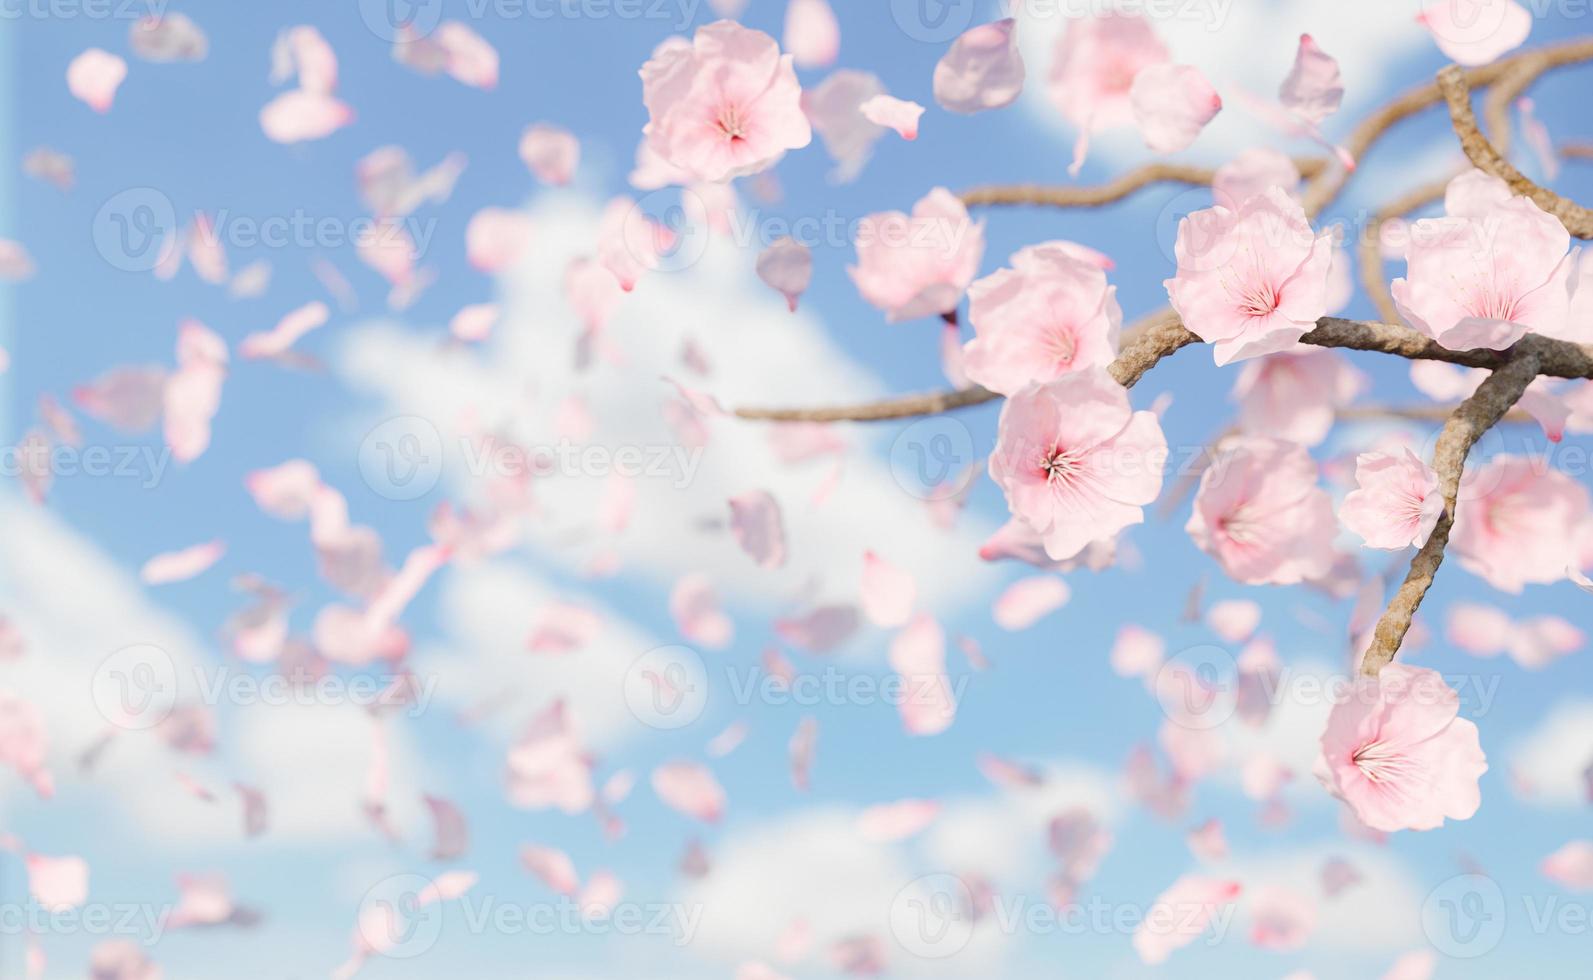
[1184,437,1338,585]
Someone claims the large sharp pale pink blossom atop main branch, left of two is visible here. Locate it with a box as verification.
[1166,186,1333,367]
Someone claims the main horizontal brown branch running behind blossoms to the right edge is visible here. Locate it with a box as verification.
[736,316,1593,422]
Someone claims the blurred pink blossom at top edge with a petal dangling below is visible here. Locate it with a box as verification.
[1047,11,1172,175]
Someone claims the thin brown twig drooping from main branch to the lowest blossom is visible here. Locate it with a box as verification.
[1360,351,1539,677]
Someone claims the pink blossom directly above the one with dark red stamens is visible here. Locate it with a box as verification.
[964,242,1123,395]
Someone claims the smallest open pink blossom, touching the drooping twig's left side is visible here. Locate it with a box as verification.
[1338,449,1443,550]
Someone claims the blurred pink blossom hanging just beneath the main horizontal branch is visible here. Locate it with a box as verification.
[1233,347,1368,446]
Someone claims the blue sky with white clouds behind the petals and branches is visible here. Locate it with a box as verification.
[0,0,1593,980]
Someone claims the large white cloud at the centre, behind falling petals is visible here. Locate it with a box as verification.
[335,194,994,612]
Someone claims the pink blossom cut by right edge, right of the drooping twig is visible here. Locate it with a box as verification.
[1450,454,1593,593]
